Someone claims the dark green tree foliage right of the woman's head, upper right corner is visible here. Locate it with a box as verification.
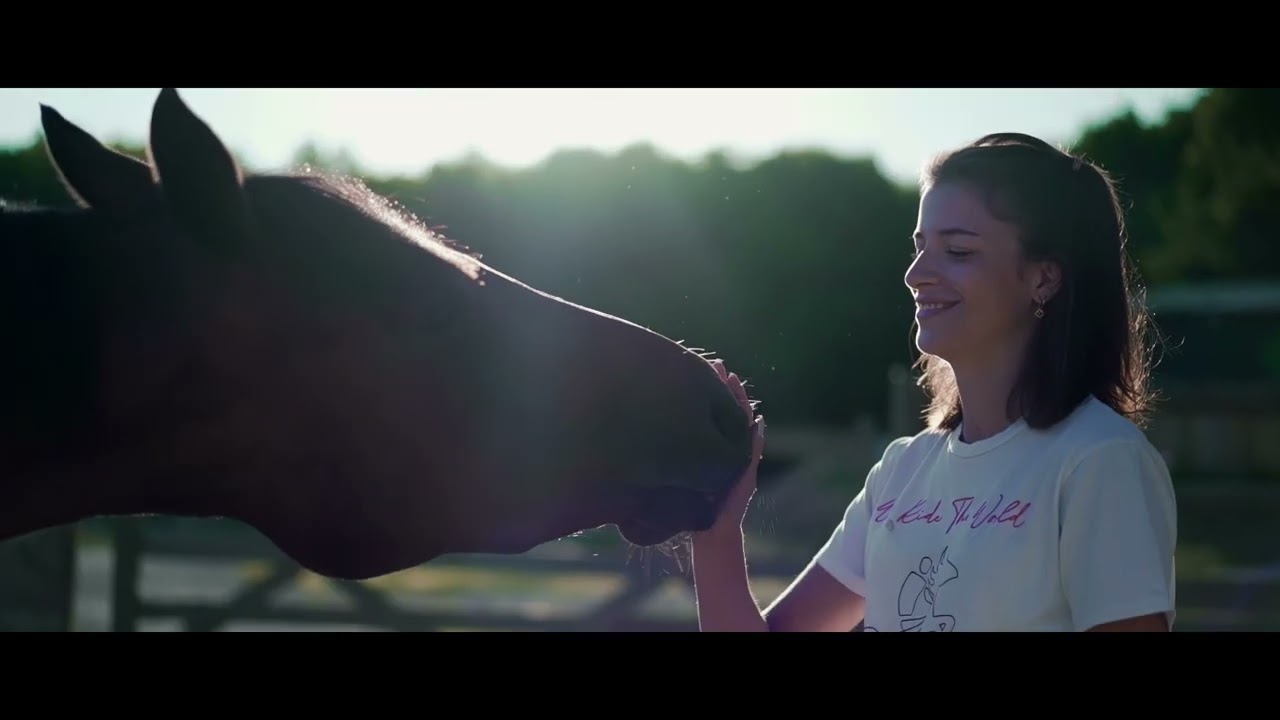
[1076,87,1280,283]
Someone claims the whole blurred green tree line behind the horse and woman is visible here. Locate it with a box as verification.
[0,88,1280,424]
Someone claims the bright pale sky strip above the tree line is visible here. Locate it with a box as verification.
[0,88,1199,182]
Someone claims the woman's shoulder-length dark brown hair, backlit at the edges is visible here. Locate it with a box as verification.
[916,132,1153,429]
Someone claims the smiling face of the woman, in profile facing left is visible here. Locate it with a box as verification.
[904,183,1053,368]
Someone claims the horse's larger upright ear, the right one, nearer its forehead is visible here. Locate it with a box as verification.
[147,87,250,242]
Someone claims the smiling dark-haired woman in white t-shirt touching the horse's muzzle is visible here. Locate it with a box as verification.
[692,133,1176,632]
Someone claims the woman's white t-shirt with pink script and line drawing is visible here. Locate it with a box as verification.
[812,397,1178,632]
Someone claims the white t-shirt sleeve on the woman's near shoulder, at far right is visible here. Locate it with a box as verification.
[1059,430,1178,630]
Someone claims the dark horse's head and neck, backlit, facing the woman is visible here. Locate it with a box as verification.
[0,90,751,579]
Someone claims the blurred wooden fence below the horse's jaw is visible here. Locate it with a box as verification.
[111,519,799,632]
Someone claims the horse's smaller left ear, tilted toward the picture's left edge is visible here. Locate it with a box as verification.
[40,104,155,210]
